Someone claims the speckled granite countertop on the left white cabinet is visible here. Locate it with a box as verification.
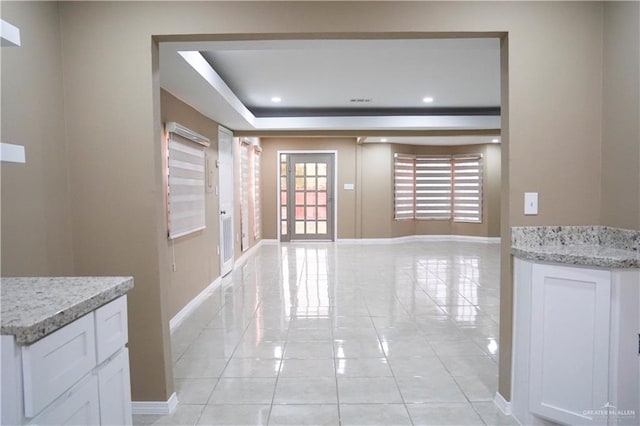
[0,277,133,345]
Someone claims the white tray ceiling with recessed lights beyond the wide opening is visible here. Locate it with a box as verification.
[160,38,500,139]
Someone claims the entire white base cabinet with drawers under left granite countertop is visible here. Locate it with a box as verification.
[0,296,132,426]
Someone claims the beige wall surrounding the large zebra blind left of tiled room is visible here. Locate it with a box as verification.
[160,90,220,317]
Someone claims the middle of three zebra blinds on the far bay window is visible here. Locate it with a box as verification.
[415,155,451,219]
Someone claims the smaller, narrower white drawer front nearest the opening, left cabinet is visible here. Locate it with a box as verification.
[96,296,128,364]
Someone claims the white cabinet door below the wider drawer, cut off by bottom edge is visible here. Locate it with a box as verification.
[29,375,100,426]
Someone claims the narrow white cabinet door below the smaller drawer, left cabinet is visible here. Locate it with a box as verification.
[98,348,132,426]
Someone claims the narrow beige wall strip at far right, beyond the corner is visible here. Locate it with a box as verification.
[602,2,640,229]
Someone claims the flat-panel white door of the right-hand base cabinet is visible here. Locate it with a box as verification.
[529,264,611,424]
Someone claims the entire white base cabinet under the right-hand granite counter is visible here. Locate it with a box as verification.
[511,258,640,425]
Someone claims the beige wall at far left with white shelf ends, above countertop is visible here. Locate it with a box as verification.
[0,2,74,276]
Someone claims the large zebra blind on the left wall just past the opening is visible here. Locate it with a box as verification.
[167,133,206,239]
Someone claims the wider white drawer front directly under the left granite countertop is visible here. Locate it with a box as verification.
[22,313,96,417]
